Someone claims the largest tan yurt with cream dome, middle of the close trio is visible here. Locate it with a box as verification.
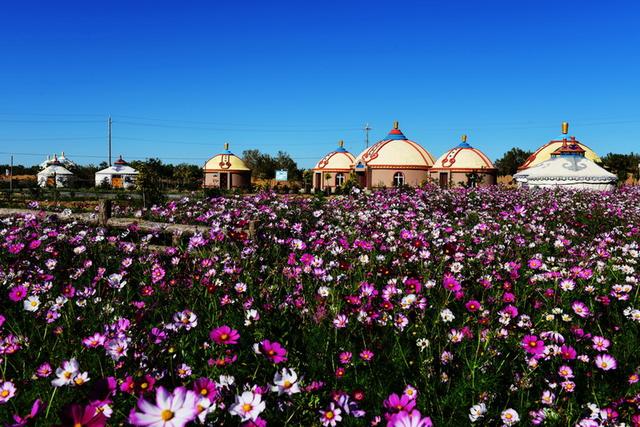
[353,122,435,188]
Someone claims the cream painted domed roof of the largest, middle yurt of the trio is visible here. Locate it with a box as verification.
[354,122,434,170]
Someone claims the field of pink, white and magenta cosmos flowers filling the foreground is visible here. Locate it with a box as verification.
[0,187,640,427]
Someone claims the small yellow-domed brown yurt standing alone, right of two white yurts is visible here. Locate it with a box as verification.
[203,144,251,190]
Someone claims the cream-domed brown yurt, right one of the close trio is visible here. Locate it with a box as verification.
[429,135,498,188]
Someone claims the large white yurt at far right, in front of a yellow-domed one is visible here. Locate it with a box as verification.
[513,123,617,191]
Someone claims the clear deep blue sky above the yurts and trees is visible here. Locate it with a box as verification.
[0,0,640,167]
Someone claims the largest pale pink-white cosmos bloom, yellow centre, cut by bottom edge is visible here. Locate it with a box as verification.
[129,387,198,427]
